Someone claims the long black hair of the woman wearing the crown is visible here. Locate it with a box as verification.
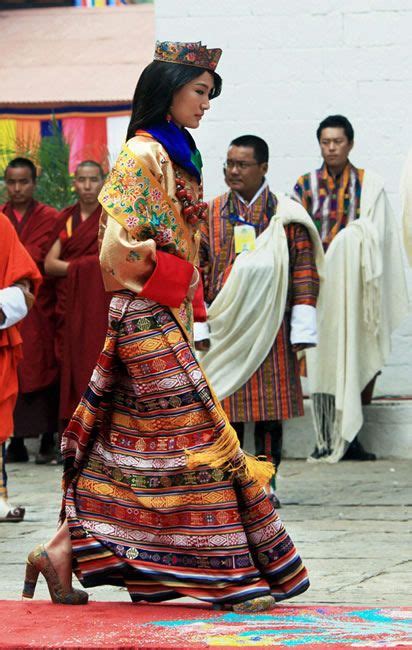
[127,61,222,140]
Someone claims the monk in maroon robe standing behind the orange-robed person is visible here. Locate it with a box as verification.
[0,158,58,462]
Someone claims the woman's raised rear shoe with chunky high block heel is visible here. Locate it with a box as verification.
[22,544,89,605]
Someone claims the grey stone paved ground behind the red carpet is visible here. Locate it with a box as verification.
[0,460,412,606]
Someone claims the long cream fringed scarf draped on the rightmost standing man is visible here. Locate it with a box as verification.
[306,172,408,462]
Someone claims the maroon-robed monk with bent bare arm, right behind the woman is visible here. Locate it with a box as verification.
[45,161,110,426]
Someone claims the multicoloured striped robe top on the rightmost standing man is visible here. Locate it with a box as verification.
[294,162,364,250]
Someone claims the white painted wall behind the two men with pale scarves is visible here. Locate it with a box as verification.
[155,0,412,395]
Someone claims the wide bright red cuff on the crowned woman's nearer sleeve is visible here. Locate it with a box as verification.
[139,251,194,307]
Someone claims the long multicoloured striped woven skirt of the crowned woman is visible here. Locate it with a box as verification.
[62,291,309,603]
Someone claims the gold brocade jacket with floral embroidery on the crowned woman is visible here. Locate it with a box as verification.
[99,134,202,338]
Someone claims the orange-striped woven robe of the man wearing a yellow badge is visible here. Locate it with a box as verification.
[200,188,319,422]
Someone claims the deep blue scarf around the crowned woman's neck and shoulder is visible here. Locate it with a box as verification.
[144,120,202,183]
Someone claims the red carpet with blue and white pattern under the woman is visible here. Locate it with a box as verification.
[0,600,412,650]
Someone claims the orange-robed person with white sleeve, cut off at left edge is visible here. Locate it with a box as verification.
[0,212,41,522]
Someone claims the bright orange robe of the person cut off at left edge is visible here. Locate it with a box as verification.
[0,212,41,443]
